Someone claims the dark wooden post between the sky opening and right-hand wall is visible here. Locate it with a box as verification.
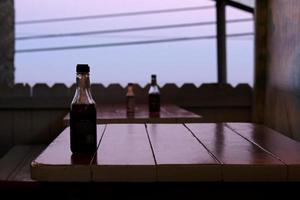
[252,0,269,124]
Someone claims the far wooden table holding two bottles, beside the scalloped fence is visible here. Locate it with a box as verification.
[64,104,202,125]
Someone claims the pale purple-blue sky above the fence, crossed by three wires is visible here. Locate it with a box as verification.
[15,0,253,86]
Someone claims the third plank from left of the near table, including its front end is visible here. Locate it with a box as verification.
[147,124,221,181]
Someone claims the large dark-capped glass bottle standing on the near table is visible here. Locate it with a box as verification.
[70,64,97,154]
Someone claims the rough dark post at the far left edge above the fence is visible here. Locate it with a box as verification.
[0,0,15,86]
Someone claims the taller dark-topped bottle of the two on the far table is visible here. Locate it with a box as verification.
[148,74,160,117]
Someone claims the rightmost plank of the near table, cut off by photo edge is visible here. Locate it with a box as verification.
[227,123,300,181]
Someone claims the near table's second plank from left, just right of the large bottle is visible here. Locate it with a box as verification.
[92,124,155,182]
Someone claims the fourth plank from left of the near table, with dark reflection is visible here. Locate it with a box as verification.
[186,123,287,181]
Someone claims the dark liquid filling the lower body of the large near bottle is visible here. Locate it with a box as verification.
[70,104,97,154]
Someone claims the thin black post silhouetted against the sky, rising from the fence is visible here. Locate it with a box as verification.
[216,0,227,83]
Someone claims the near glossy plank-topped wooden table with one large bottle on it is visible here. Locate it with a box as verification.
[31,123,300,182]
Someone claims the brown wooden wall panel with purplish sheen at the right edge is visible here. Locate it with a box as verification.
[257,0,300,141]
